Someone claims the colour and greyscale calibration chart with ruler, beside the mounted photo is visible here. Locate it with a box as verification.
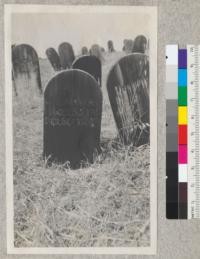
[166,45,200,219]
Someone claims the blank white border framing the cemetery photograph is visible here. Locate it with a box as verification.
[4,4,157,255]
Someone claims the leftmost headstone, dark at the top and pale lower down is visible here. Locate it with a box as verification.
[12,44,42,95]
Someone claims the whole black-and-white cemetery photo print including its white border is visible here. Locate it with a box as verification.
[5,5,157,254]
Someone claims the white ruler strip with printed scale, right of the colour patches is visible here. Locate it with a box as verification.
[187,45,200,219]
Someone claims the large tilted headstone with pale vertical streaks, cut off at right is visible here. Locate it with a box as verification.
[107,54,150,146]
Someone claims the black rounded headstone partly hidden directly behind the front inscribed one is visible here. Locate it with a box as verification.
[72,55,101,86]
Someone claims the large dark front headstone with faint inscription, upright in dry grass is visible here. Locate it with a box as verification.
[43,69,102,169]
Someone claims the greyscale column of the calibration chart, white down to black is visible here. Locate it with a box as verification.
[166,45,178,219]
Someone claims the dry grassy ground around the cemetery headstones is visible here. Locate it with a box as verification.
[13,52,150,247]
